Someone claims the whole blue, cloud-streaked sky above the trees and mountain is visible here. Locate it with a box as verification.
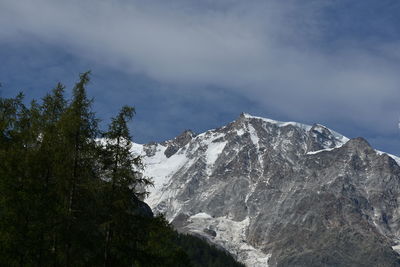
[0,0,400,155]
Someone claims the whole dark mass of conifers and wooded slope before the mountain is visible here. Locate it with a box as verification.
[0,72,244,266]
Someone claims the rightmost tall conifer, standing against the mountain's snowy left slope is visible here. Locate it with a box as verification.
[103,106,150,266]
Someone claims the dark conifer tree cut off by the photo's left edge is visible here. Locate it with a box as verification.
[0,93,25,265]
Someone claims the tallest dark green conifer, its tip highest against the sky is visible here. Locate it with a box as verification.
[57,72,98,266]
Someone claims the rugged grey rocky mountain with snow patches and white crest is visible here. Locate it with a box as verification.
[134,114,400,266]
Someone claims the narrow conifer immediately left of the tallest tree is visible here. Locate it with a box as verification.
[38,83,67,266]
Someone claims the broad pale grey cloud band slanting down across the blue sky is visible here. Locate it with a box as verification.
[0,0,400,138]
